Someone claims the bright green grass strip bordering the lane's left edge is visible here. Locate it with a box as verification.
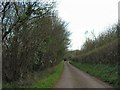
[32,62,63,88]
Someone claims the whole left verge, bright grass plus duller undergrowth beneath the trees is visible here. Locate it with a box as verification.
[3,62,64,89]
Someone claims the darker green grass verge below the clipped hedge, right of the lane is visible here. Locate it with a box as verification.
[70,61,118,88]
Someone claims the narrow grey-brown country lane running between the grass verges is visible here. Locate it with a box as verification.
[55,61,112,88]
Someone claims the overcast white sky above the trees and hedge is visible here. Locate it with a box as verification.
[57,0,119,50]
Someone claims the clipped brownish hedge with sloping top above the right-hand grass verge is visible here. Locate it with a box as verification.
[73,39,118,64]
